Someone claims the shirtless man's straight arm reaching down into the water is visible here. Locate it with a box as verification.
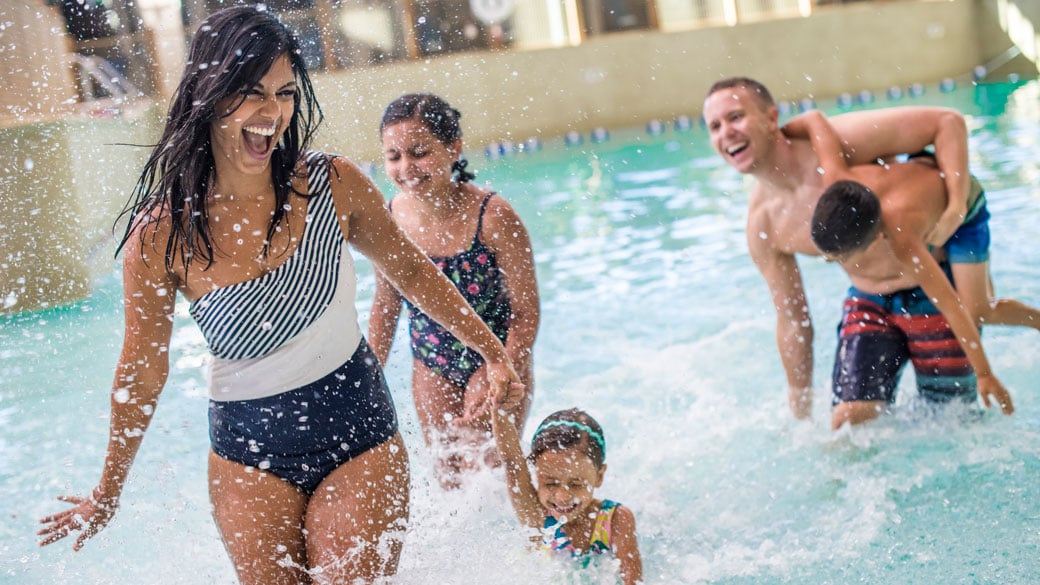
[748,220,812,418]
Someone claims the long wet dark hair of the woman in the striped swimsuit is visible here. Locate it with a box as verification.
[116,6,322,270]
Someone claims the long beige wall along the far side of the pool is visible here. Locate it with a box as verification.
[314,0,1023,161]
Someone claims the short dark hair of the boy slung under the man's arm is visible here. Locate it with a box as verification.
[811,181,881,255]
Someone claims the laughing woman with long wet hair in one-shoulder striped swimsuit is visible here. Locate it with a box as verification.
[41,6,523,584]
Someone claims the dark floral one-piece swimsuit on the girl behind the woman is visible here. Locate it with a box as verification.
[405,193,513,387]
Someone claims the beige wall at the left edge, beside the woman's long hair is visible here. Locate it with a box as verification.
[0,108,159,314]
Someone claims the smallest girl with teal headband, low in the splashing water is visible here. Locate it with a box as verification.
[492,408,643,585]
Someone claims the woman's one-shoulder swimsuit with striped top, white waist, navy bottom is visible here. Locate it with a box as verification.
[190,152,397,493]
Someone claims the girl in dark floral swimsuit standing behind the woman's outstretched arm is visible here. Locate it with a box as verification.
[368,94,539,487]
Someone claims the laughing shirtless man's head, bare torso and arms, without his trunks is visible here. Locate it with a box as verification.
[704,77,969,418]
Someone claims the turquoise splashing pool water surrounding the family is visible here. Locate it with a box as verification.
[0,82,1040,585]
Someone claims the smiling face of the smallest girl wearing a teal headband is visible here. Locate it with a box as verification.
[535,449,606,520]
